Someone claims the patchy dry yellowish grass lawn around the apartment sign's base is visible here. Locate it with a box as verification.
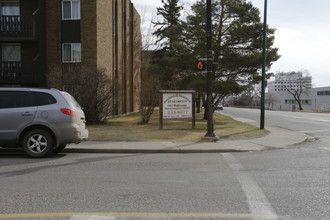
[88,111,268,142]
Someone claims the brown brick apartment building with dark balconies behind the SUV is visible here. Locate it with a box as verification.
[0,0,141,115]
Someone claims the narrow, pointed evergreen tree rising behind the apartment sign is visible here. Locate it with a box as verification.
[151,0,192,89]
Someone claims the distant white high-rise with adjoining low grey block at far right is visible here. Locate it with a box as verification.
[265,72,330,111]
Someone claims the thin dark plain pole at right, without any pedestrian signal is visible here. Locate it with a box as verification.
[260,0,267,129]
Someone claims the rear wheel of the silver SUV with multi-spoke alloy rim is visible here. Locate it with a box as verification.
[22,129,54,157]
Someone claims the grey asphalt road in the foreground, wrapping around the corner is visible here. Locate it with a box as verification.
[0,108,330,220]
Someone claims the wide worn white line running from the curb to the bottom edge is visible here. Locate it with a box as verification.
[222,153,278,220]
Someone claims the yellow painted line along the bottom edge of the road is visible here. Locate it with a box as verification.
[0,212,274,220]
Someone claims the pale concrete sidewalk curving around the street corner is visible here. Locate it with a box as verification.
[65,124,309,153]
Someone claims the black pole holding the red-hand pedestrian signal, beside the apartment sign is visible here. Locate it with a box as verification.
[205,0,215,137]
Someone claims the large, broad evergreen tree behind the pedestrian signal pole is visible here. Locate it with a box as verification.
[184,0,280,109]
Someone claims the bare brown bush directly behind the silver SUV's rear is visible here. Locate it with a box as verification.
[47,64,114,124]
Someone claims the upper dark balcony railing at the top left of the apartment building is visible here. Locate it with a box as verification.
[0,15,36,38]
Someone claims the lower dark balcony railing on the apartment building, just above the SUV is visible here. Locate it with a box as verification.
[0,61,40,85]
